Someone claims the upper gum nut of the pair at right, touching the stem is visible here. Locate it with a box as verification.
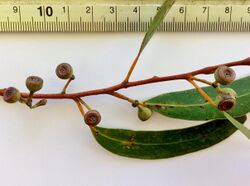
[214,66,236,85]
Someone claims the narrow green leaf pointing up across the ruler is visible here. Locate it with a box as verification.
[139,0,175,53]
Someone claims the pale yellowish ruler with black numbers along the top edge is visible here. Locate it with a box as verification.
[0,0,250,32]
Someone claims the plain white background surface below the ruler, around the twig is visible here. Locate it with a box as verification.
[0,33,250,186]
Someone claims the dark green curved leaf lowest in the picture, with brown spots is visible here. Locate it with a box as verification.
[92,116,246,159]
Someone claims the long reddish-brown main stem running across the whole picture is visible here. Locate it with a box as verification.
[0,58,250,99]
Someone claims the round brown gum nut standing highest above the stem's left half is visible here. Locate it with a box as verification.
[56,63,73,79]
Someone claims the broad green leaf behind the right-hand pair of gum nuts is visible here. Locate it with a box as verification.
[145,76,250,120]
